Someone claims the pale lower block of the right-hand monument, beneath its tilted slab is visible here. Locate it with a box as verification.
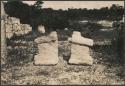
[69,44,93,65]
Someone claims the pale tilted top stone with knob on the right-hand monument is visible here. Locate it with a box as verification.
[69,31,94,46]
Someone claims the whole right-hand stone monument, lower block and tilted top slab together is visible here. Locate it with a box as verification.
[69,31,93,65]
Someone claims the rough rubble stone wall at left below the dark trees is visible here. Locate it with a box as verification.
[5,17,32,38]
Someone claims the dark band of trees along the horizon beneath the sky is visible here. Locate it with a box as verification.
[5,0,124,31]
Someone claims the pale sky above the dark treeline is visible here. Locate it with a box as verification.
[23,1,124,10]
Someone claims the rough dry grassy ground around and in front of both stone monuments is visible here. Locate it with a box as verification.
[1,28,125,85]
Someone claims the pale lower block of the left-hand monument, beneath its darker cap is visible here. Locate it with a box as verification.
[34,43,58,65]
